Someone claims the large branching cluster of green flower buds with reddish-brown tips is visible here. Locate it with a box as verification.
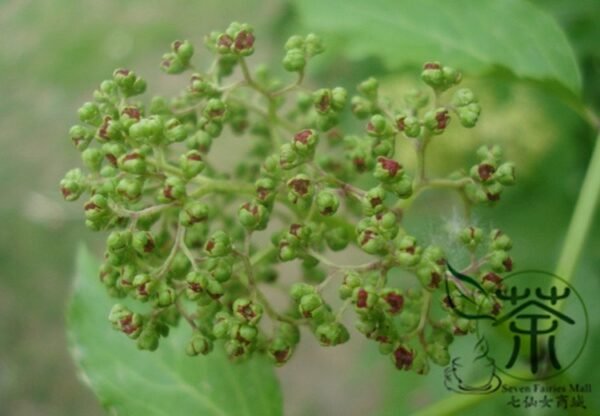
[60,23,514,374]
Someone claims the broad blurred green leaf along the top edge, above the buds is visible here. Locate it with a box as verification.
[297,0,581,95]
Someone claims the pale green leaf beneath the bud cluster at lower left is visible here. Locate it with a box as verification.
[67,248,282,416]
